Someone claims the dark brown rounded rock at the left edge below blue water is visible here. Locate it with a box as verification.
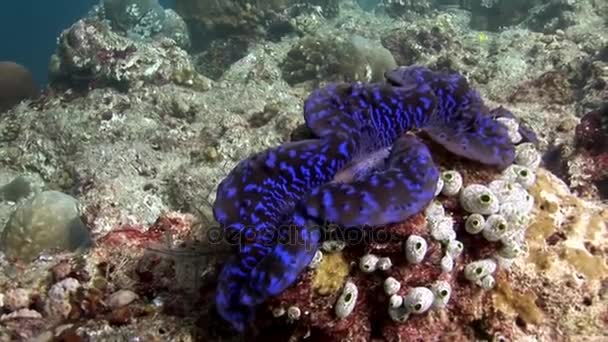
[0,61,38,115]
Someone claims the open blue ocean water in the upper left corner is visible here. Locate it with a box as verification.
[0,0,175,86]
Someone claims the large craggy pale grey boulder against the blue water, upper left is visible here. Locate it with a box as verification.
[49,19,211,91]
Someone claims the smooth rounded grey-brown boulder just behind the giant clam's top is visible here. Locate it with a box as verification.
[281,35,397,85]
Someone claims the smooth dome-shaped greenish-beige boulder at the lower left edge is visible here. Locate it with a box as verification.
[0,191,91,262]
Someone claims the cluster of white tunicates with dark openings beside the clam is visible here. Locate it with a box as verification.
[410,143,541,314]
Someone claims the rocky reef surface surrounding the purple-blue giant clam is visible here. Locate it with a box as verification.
[0,0,608,341]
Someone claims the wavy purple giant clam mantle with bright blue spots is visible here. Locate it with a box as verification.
[213,66,536,331]
